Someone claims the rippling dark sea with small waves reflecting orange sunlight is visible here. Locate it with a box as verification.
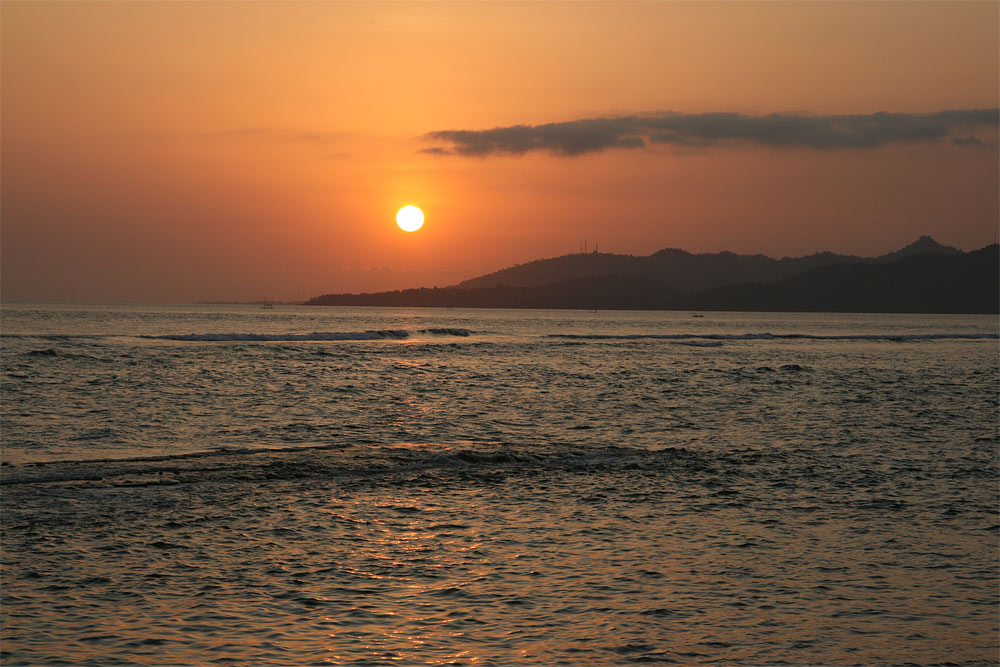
[0,304,1000,667]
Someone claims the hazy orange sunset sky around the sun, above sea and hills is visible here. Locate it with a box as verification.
[0,0,1000,303]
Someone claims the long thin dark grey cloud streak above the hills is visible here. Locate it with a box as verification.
[421,109,1000,157]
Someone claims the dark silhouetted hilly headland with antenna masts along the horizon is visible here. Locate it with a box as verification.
[306,236,1000,313]
